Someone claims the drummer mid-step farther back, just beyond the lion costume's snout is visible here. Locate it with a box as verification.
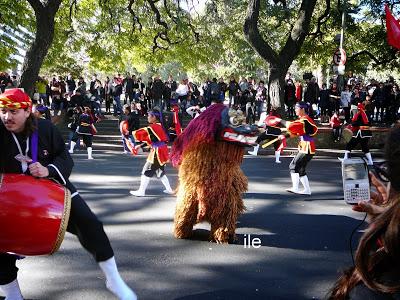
[248,109,286,164]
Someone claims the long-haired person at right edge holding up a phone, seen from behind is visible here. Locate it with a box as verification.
[328,127,400,300]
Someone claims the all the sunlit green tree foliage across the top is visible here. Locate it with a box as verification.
[0,0,400,81]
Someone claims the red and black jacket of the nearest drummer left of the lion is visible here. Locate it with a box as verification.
[132,123,169,166]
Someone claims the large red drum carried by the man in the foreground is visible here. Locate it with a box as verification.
[0,174,71,255]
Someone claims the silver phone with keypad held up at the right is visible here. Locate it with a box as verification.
[342,157,370,205]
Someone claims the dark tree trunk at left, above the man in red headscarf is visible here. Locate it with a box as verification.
[20,0,62,96]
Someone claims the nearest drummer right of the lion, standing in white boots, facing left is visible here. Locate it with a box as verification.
[281,101,318,195]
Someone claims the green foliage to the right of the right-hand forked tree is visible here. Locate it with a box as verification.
[297,0,400,74]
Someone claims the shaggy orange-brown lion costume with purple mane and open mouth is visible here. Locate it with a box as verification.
[171,104,257,243]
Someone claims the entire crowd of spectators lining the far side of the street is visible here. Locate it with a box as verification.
[0,72,400,126]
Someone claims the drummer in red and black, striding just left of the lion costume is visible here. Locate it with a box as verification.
[130,109,173,197]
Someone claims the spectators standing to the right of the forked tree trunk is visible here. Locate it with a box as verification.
[285,77,400,126]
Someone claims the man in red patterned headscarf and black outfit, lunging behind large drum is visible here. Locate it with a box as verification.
[0,89,137,300]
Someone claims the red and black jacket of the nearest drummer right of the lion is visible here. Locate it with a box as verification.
[287,115,318,154]
